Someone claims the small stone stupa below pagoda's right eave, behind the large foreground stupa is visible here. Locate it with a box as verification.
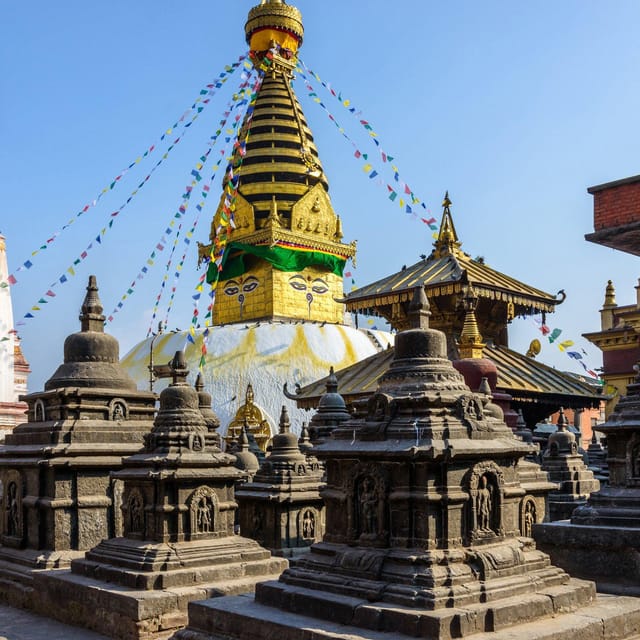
[542,409,600,521]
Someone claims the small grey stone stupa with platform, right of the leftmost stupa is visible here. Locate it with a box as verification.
[35,351,286,640]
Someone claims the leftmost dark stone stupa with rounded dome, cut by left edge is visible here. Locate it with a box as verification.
[0,276,156,601]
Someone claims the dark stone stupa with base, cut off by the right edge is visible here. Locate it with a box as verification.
[534,368,640,596]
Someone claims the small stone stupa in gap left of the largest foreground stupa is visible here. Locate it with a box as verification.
[236,407,324,557]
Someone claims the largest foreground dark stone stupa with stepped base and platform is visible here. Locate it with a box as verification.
[177,288,640,640]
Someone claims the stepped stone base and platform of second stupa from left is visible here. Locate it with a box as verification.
[34,536,287,640]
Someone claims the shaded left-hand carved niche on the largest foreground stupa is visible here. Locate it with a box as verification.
[347,465,389,547]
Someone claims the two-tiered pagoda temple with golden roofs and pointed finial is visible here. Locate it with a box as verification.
[293,193,602,428]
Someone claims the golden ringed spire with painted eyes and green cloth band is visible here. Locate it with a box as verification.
[200,0,356,324]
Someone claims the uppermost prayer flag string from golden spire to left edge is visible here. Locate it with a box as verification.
[7,54,251,285]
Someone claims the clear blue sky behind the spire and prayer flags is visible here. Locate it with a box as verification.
[0,0,640,390]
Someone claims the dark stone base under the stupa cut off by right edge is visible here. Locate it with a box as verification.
[533,520,640,597]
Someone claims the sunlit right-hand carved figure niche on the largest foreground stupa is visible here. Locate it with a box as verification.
[468,461,504,544]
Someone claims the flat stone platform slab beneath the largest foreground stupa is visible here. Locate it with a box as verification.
[175,580,640,640]
